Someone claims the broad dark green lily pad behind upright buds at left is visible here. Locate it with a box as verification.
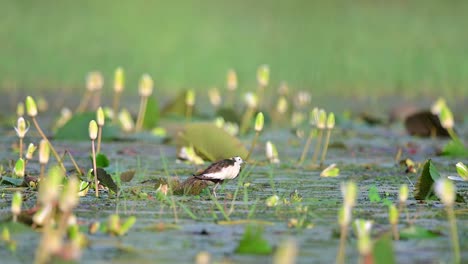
[54,112,119,141]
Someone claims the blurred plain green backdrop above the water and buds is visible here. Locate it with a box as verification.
[0,0,468,97]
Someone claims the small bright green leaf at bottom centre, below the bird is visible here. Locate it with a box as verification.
[236,225,273,255]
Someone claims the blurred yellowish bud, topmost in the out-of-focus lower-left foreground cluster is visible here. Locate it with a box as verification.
[38,166,63,205]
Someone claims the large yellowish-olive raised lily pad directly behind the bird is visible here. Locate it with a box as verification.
[178,123,248,161]
